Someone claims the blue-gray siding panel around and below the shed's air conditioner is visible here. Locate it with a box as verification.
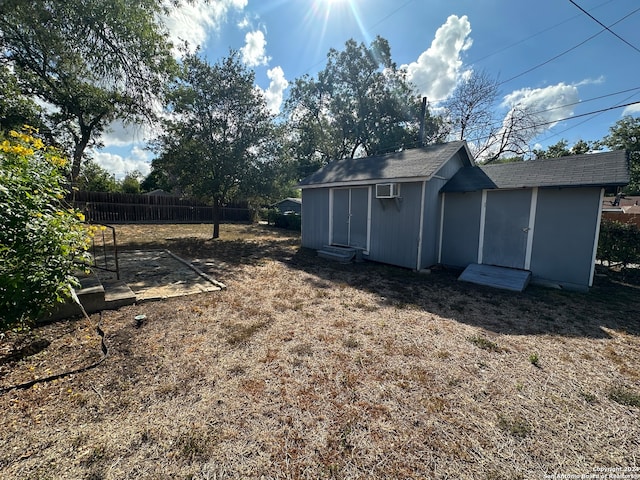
[368,182,422,268]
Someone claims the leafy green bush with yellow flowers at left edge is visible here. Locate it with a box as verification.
[0,127,90,331]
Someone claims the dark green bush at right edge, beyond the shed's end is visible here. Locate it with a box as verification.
[598,220,640,268]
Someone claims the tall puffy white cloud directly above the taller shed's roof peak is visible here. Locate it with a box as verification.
[402,15,472,102]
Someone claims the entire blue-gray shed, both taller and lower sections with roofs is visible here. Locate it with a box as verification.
[298,141,629,289]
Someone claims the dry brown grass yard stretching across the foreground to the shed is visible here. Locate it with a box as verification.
[0,225,640,480]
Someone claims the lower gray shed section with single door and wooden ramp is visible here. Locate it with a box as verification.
[438,151,629,290]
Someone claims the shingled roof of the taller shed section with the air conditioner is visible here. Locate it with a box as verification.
[298,141,473,188]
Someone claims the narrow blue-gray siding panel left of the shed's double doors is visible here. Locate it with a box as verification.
[301,188,329,250]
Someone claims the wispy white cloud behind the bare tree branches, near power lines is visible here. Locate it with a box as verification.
[502,83,580,128]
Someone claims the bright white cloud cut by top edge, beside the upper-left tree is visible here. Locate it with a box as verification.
[164,0,248,56]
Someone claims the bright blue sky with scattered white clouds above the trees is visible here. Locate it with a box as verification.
[94,0,640,178]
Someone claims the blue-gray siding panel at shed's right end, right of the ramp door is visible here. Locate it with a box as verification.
[531,188,600,289]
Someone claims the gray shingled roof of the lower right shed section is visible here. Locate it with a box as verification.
[441,150,629,192]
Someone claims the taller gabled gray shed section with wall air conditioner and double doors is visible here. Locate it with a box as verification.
[298,141,472,270]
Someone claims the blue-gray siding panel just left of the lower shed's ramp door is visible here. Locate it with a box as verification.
[440,192,482,268]
